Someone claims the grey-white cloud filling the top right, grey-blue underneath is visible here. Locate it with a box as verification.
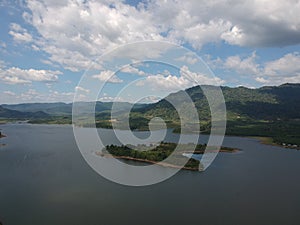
[146,0,300,47]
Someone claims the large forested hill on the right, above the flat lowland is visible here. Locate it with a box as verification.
[140,84,300,120]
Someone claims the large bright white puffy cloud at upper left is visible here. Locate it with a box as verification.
[27,1,164,71]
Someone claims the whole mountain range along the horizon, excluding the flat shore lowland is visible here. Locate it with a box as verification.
[2,84,300,120]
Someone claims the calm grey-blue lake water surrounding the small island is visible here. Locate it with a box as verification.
[0,124,300,225]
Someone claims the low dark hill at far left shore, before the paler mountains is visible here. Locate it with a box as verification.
[0,106,49,120]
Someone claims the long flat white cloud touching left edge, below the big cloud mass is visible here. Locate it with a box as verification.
[0,67,62,84]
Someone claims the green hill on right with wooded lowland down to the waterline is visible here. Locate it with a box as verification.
[134,84,300,146]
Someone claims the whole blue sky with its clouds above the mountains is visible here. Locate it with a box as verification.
[0,0,300,104]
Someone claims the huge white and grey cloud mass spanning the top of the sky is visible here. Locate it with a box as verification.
[21,0,300,71]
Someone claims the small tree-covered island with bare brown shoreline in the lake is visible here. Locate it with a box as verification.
[96,142,238,171]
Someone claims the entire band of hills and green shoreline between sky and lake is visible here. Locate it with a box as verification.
[0,84,300,146]
